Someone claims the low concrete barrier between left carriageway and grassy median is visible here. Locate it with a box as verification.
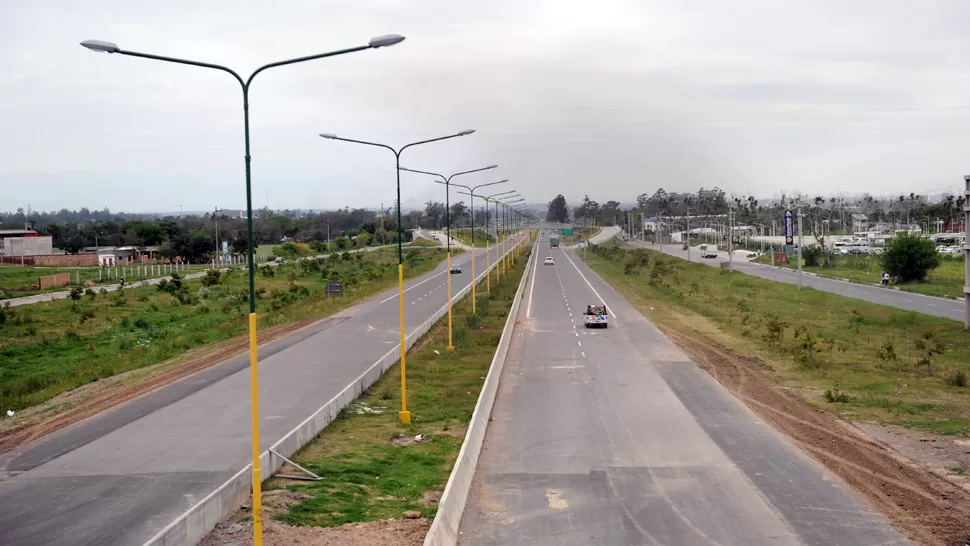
[144,234,531,546]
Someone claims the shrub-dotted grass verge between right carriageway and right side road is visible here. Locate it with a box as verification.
[587,247,970,436]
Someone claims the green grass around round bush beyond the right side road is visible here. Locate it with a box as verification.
[755,251,964,298]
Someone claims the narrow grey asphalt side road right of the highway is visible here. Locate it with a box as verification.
[630,241,966,322]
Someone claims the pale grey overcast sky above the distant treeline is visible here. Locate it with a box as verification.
[0,0,970,211]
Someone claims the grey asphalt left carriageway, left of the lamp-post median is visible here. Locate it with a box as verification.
[0,235,520,546]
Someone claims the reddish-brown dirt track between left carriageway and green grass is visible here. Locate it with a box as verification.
[0,318,320,453]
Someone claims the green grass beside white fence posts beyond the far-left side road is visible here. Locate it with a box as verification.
[0,264,209,300]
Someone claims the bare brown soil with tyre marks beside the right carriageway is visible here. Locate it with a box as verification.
[660,326,970,546]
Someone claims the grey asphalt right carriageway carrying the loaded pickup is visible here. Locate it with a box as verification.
[460,244,909,546]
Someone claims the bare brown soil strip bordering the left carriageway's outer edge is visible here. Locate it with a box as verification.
[0,318,319,453]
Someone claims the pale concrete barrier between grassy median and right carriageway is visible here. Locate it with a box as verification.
[424,237,536,546]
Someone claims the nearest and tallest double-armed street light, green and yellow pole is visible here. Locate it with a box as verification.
[81,34,404,546]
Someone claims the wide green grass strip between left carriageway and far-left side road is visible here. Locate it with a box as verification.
[0,245,445,411]
